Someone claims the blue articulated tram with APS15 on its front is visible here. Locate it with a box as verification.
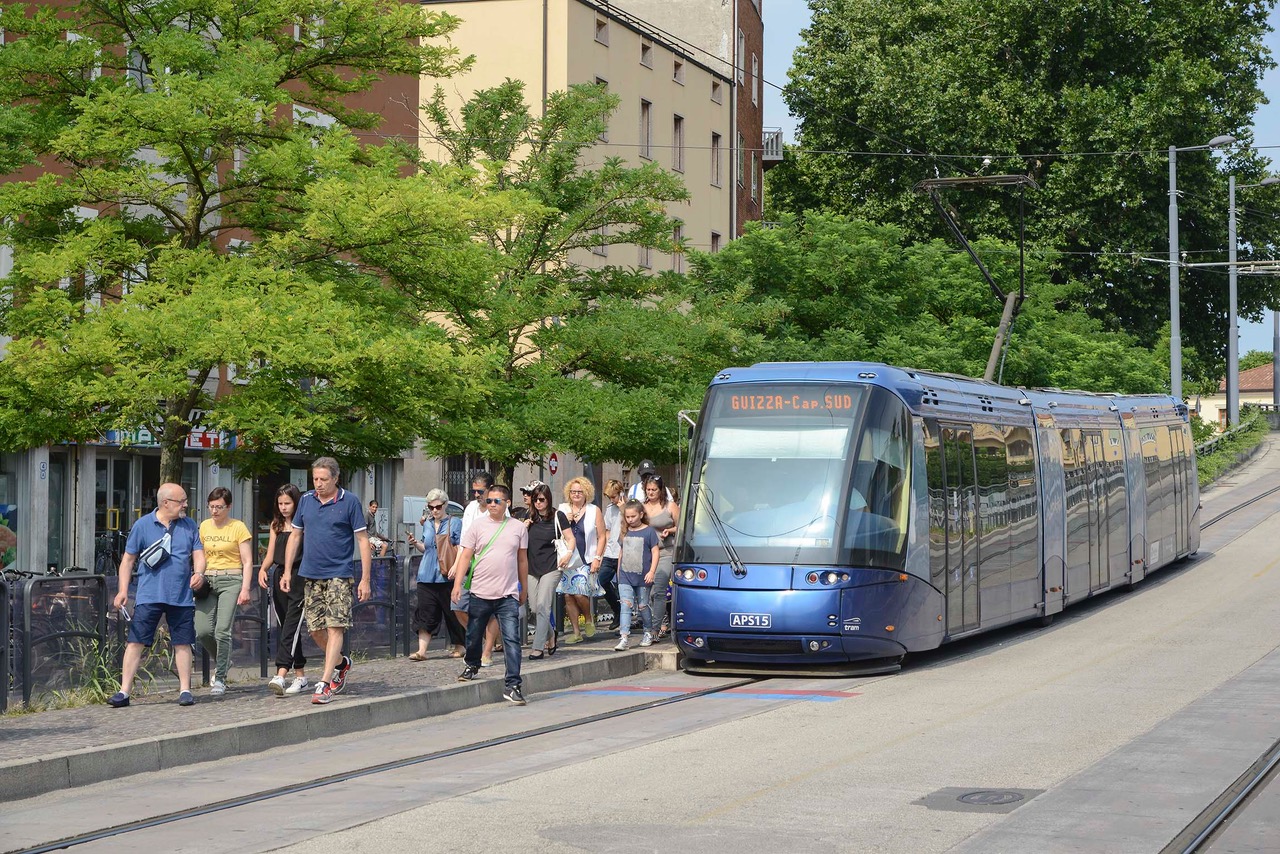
[672,362,1199,675]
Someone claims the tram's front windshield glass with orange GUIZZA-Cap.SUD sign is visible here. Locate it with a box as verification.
[677,384,911,570]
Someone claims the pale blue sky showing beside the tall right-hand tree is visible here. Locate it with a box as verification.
[764,0,1280,355]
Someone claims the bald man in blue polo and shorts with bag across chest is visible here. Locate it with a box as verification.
[106,484,205,708]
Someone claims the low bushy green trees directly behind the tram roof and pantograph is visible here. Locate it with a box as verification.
[691,214,1169,392]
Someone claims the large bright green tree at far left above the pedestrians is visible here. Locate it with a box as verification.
[0,0,509,480]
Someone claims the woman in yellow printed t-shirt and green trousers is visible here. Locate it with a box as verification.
[196,487,253,697]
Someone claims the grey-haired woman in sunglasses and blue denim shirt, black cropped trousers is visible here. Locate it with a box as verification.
[406,489,463,661]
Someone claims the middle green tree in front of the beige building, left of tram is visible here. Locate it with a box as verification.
[407,81,751,480]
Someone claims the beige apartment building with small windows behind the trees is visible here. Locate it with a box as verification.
[420,0,732,265]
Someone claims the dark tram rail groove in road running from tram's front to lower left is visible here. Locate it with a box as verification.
[8,676,768,854]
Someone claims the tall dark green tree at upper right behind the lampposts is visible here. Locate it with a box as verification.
[769,0,1280,376]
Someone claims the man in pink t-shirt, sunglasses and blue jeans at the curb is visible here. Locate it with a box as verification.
[453,485,529,705]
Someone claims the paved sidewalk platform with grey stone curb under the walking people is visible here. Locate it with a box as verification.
[0,632,676,803]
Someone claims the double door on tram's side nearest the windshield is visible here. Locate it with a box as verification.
[942,425,980,635]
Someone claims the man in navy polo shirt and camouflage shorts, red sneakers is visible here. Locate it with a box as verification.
[280,457,371,704]
